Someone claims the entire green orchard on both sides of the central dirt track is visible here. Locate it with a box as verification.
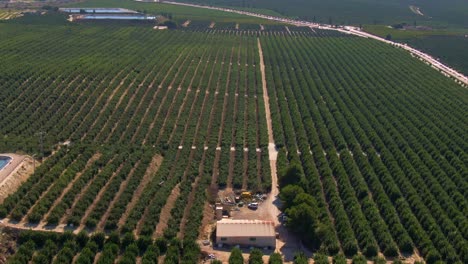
[0,0,468,263]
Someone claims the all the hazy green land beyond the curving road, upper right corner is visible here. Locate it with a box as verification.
[175,0,468,80]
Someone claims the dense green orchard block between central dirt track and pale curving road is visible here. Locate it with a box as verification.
[261,32,468,263]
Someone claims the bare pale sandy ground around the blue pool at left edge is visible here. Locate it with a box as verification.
[0,153,34,203]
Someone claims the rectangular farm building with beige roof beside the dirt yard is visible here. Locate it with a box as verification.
[216,219,276,248]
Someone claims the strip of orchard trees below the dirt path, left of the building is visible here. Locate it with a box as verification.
[8,231,203,264]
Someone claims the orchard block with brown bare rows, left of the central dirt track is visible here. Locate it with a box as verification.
[0,19,271,241]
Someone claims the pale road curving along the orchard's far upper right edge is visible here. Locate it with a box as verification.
[164,1,468,87]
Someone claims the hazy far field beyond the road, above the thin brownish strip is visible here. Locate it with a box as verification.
[176,0,468,28]
